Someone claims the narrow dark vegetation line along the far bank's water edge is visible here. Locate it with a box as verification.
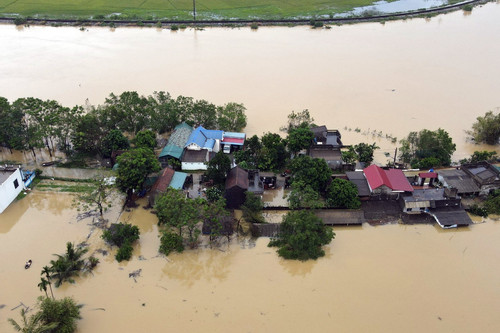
[0,0,491,26]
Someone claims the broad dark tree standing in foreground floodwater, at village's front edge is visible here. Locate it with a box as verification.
[269,210,335,260]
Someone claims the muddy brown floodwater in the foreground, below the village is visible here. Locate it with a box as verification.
[0,191,500,332]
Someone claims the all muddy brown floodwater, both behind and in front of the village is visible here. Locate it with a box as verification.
[0,3,500,332]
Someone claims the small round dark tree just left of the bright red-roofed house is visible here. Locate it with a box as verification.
[326,178,361,209]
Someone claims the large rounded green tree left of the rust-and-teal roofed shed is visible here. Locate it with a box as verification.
[116,148,160,202]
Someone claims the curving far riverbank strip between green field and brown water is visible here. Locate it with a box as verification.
[0,0,488,30]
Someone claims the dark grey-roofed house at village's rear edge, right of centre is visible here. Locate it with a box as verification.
[308,125,343,170]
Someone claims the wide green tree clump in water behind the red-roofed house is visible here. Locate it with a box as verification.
[400,128,456,166]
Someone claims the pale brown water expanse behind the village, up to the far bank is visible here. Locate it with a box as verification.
[0,2,500,163]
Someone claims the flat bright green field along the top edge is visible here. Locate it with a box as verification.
[0,0,398,20]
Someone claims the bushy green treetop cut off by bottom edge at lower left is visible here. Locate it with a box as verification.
[39,297,82,333]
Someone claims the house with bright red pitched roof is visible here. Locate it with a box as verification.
[363,164,413,195]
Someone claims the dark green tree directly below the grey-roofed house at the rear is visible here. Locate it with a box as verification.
[289,156,332,192]
